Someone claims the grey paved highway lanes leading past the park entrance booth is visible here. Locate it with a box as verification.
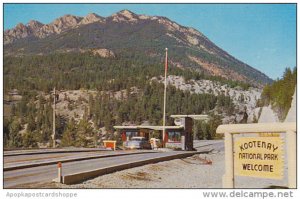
[3,141,223,188]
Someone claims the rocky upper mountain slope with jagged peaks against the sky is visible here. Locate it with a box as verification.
[4,10,272,85]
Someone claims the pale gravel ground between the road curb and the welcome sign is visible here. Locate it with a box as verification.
[57,153,224,188]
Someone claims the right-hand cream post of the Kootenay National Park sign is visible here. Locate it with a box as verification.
[286,131,297,189]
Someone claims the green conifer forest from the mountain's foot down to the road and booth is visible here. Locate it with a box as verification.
[4,53,237,147]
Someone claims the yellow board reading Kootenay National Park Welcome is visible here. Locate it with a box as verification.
[234,137,284,179]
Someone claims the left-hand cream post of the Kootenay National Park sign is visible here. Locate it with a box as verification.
[223,133,234,188]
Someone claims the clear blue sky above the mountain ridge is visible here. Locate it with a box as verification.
[4,4,296,79]
